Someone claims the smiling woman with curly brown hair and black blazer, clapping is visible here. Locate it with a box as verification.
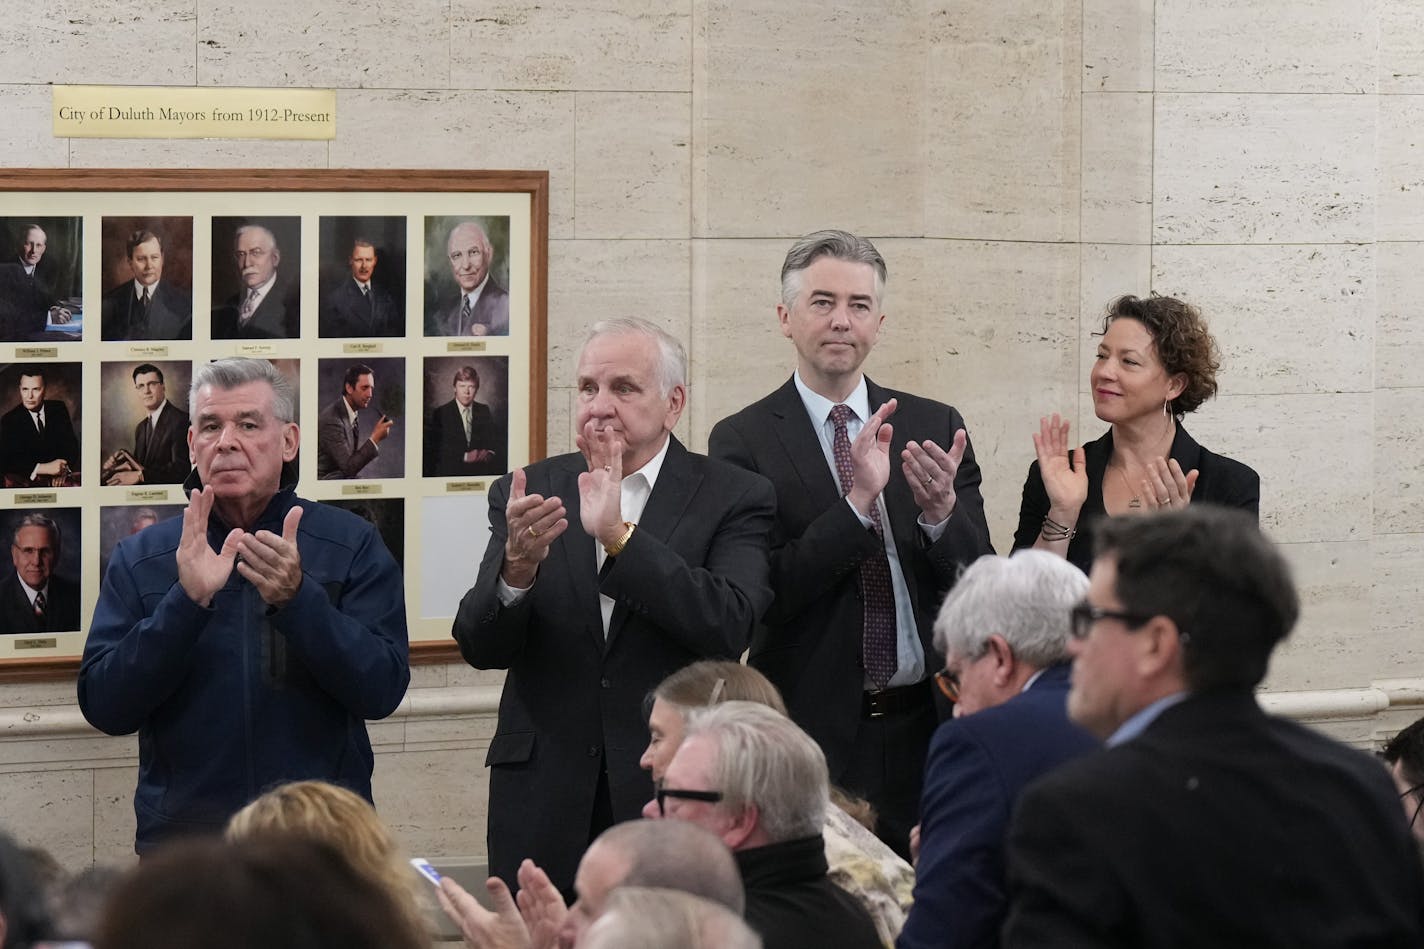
[1014,296,1260,571]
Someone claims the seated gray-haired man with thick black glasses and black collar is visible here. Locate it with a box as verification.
[644,701,881,949]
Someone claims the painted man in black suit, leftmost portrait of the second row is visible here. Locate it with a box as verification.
[0,365,80,487]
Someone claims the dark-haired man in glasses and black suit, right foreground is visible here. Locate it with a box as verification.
[1002,504,1424,949]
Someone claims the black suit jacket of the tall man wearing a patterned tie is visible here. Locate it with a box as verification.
[708,378,994,782]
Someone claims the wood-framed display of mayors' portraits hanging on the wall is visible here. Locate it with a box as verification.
[0,168,548,672]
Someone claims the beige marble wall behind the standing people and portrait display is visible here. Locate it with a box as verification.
[0,0,1424,856]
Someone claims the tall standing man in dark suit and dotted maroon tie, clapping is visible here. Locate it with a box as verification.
[708,231,993,855]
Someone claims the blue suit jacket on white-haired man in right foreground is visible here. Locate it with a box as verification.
[896,663,1098,949]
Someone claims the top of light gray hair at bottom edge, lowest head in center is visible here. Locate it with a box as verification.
[582,886,762,949]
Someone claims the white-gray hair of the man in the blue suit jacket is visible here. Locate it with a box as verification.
[934,550,1088,668]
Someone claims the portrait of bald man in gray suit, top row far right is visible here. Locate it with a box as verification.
[426,218,510,336]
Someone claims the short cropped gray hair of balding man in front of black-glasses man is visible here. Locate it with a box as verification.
[594,821,746,915]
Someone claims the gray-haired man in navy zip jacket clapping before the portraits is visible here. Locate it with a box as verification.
[78,358,410,854]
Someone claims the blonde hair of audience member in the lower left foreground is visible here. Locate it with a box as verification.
[226,781,430,933]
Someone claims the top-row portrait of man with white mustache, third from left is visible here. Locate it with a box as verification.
[212,218,302,339]
